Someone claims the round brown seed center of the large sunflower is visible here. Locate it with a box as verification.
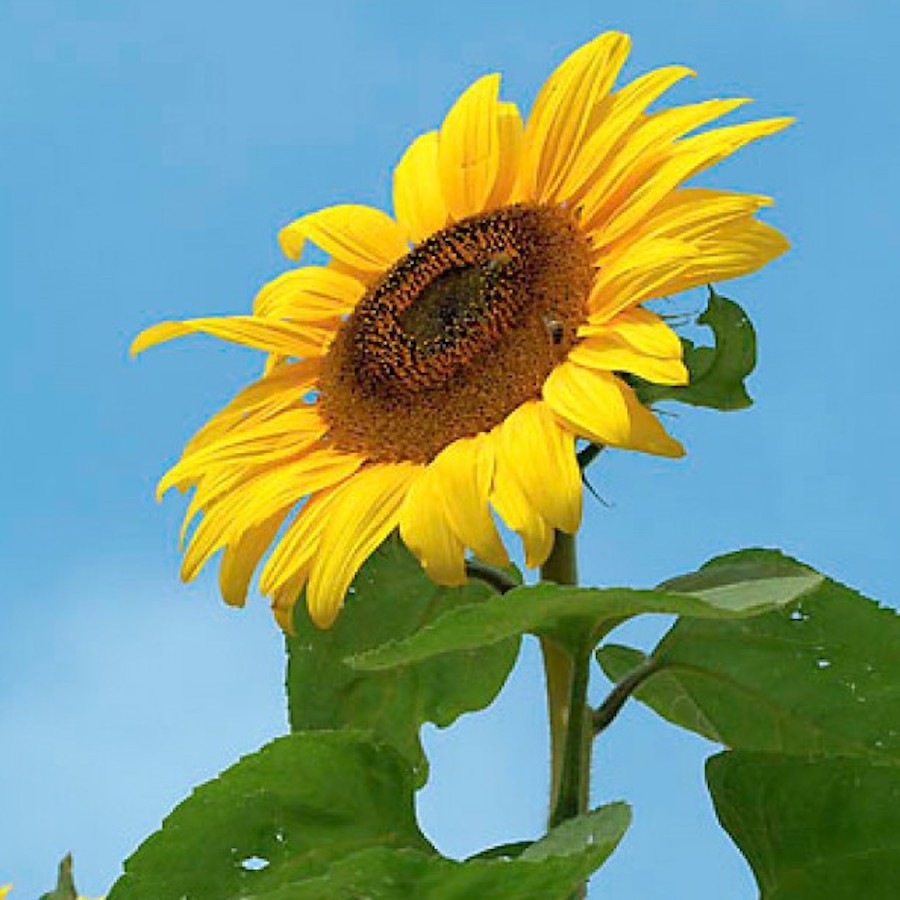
[319,205,592,462]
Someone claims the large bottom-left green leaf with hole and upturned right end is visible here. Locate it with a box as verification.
[109,731,630,900]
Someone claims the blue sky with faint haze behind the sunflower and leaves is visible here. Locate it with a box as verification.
[0,0,900,900]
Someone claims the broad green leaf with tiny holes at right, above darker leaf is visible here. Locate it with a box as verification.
[598,551,900,761]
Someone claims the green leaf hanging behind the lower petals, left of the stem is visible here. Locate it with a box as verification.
[287,540,519,784]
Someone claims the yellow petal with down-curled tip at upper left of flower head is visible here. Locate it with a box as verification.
[278,203,409,272]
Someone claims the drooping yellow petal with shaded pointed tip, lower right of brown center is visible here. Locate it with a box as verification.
[543,362,684,457]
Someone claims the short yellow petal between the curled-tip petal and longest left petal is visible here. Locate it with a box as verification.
[253,266,366,322]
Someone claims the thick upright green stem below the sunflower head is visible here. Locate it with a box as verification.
[541,531,593,876]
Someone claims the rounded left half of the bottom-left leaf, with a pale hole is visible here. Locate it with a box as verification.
[109,731,431,900]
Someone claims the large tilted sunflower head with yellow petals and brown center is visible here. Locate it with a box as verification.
[132,32,791,629]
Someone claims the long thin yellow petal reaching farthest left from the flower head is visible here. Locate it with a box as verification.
[131,316,335,357]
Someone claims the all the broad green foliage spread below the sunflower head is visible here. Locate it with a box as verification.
[105,541,900,900]
